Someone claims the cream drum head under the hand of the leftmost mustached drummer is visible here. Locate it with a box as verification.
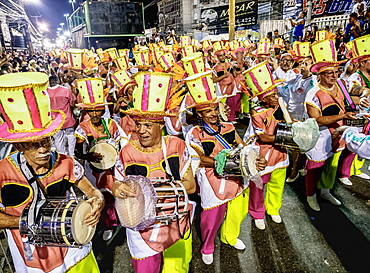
[72,201,96,245]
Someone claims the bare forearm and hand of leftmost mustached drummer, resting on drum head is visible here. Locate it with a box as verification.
[76,176,104,226]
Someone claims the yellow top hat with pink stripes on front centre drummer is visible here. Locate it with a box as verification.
[124,72,175,120]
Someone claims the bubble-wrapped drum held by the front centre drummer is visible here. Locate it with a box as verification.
[115,175,189,231]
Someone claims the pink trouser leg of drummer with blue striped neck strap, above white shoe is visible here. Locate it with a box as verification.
[200,203,227,254]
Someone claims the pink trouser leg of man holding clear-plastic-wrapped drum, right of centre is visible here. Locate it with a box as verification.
[248,173,271,219]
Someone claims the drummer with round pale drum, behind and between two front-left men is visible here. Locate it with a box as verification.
[75,78,127,240]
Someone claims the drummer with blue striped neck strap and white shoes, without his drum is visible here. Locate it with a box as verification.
[185,71,266,264]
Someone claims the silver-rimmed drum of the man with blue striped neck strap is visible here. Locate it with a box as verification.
[224,144,259,179]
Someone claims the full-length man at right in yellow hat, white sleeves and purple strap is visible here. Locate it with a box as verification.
[305,40,357,211]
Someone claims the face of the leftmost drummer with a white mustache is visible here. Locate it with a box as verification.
[15,137,51,166]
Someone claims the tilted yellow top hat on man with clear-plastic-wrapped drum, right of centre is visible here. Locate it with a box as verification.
[243,62,283,99]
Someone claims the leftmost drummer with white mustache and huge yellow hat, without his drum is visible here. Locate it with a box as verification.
[0,72,104,272]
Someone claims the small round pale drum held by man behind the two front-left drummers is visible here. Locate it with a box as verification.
[89,139,118,170]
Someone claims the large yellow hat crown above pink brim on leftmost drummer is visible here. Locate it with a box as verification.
[0,72,52,133]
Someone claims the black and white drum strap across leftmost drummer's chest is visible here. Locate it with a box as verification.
[18,153,46,229]
